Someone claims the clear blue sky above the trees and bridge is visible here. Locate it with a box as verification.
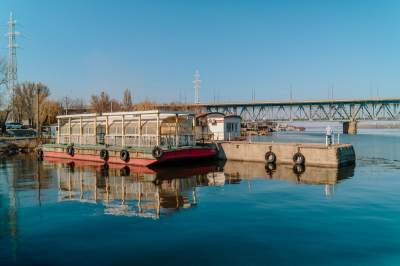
[0,0,400,102]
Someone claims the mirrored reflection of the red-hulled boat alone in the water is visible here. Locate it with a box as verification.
[55,158,218,219]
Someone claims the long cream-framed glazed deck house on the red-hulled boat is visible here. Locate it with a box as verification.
[57,110,196,147]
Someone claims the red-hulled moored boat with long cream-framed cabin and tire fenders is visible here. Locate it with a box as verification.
[37,110,217,166]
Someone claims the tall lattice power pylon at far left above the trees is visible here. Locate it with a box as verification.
[7,12,20,120]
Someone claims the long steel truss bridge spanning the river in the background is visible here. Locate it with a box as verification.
[197,98,400,133]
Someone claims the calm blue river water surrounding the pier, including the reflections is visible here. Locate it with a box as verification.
[0,130,400,265]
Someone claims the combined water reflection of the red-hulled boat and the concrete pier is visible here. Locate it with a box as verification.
[49,156,354,219]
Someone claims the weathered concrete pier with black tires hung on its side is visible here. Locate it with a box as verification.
[217,141,355,167]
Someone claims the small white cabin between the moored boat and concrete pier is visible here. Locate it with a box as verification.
[196,113,241,141]
